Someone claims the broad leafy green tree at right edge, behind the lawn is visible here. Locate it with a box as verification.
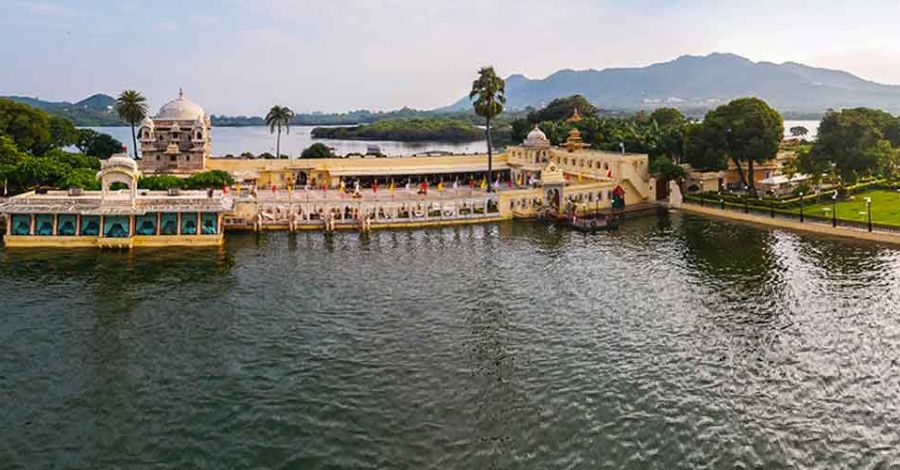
[806,108,897,180]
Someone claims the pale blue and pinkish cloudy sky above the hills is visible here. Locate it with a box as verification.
[0,0,900,115]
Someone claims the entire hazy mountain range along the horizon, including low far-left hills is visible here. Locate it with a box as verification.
[9,53,900,126]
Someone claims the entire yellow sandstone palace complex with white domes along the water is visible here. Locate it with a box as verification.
[0,95,657,248]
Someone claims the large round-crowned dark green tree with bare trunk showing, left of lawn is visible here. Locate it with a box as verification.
[702,98,784,196]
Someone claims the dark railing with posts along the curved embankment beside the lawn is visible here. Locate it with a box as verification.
[684,196,900,234]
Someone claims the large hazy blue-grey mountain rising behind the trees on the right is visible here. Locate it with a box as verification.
[441,53,900,114]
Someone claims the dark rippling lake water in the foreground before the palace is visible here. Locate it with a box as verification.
[0,214,900,469]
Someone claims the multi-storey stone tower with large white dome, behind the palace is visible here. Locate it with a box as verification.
[139,91,212,173]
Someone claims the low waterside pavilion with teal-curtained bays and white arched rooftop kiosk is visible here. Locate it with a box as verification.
[0,154,232,248]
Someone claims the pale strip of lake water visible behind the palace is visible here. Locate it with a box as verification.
[91,126,487,157]
